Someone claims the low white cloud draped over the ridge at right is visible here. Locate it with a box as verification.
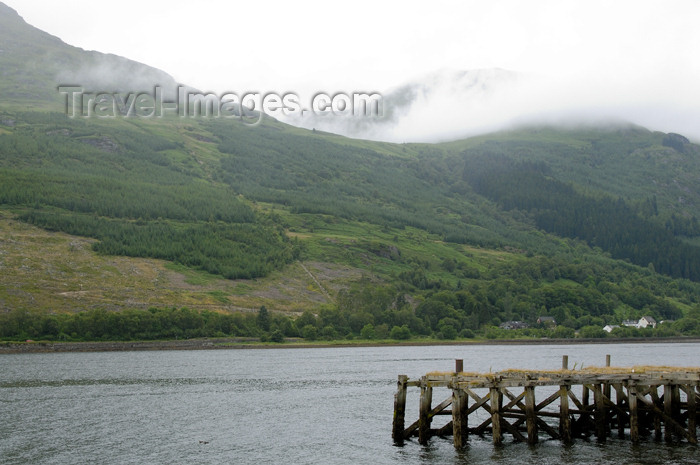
[288,69,700,142]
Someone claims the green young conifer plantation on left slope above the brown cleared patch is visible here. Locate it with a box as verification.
[0,113,298,279]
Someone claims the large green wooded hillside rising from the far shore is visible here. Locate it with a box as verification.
[0,0,700,341]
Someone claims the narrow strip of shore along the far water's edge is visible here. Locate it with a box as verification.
[0,337,700,355]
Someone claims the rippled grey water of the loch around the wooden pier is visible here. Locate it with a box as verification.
[0,344,700,465]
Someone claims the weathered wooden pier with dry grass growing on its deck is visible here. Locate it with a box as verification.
[393,356,700,449]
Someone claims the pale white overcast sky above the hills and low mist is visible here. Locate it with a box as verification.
[4,0,700,139]
